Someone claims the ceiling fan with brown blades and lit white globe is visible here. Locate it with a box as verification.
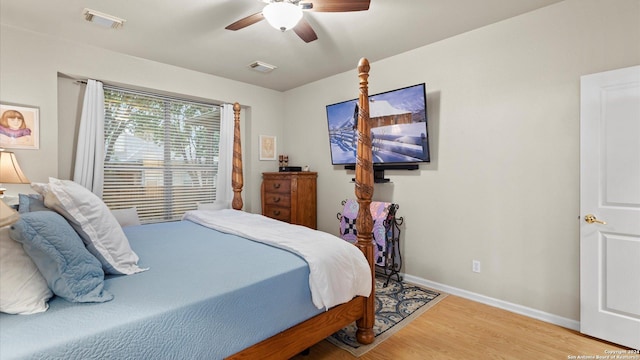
[225,0,371,43]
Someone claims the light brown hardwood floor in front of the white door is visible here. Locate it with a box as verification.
[293,295,640,360]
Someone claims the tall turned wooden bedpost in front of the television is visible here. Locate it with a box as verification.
[355,58,376,344]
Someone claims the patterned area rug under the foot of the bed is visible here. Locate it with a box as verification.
[326,276,447,357]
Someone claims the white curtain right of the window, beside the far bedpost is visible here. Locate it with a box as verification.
[209,104,234,209]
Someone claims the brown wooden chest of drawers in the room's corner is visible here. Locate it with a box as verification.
[261,171,318,229]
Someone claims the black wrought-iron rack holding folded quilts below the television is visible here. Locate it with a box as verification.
[337,200,404,287]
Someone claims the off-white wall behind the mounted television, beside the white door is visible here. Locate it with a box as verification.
[284,0,640,319]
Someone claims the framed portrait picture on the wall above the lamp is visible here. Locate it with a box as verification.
[0,102,40,149]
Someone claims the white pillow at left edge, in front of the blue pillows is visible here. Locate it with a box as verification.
[0,226,53,315]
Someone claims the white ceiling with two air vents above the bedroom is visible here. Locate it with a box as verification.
[0,0,561,91]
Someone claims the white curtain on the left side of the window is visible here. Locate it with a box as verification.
[73,80,104,198]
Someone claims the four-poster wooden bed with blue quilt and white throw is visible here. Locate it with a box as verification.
[0,59,375,359]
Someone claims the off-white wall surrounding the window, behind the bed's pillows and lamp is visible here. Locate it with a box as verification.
[0,26,283,212]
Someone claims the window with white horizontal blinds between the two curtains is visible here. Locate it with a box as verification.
[102,85,220,223]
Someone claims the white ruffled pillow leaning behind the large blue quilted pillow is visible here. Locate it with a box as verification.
[44,178,147,275]
